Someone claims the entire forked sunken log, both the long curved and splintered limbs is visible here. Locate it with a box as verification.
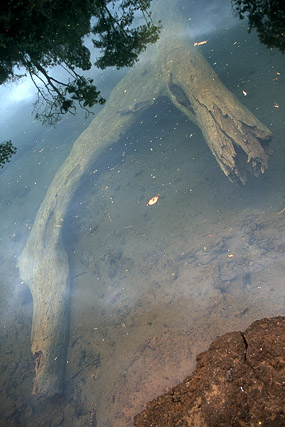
[19,0,271,396]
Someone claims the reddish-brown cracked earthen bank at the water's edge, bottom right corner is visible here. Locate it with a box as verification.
[134,317,285,427]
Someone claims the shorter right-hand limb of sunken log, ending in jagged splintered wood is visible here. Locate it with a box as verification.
[154,0,271,184]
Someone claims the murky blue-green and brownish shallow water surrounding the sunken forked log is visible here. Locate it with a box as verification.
[0,1,285,426]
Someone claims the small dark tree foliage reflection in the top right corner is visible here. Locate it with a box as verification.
[232,0,285,53]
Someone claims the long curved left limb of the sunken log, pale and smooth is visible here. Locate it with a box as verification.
[19,54,162,397]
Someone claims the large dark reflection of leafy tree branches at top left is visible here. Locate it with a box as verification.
[0,0,159,123]
